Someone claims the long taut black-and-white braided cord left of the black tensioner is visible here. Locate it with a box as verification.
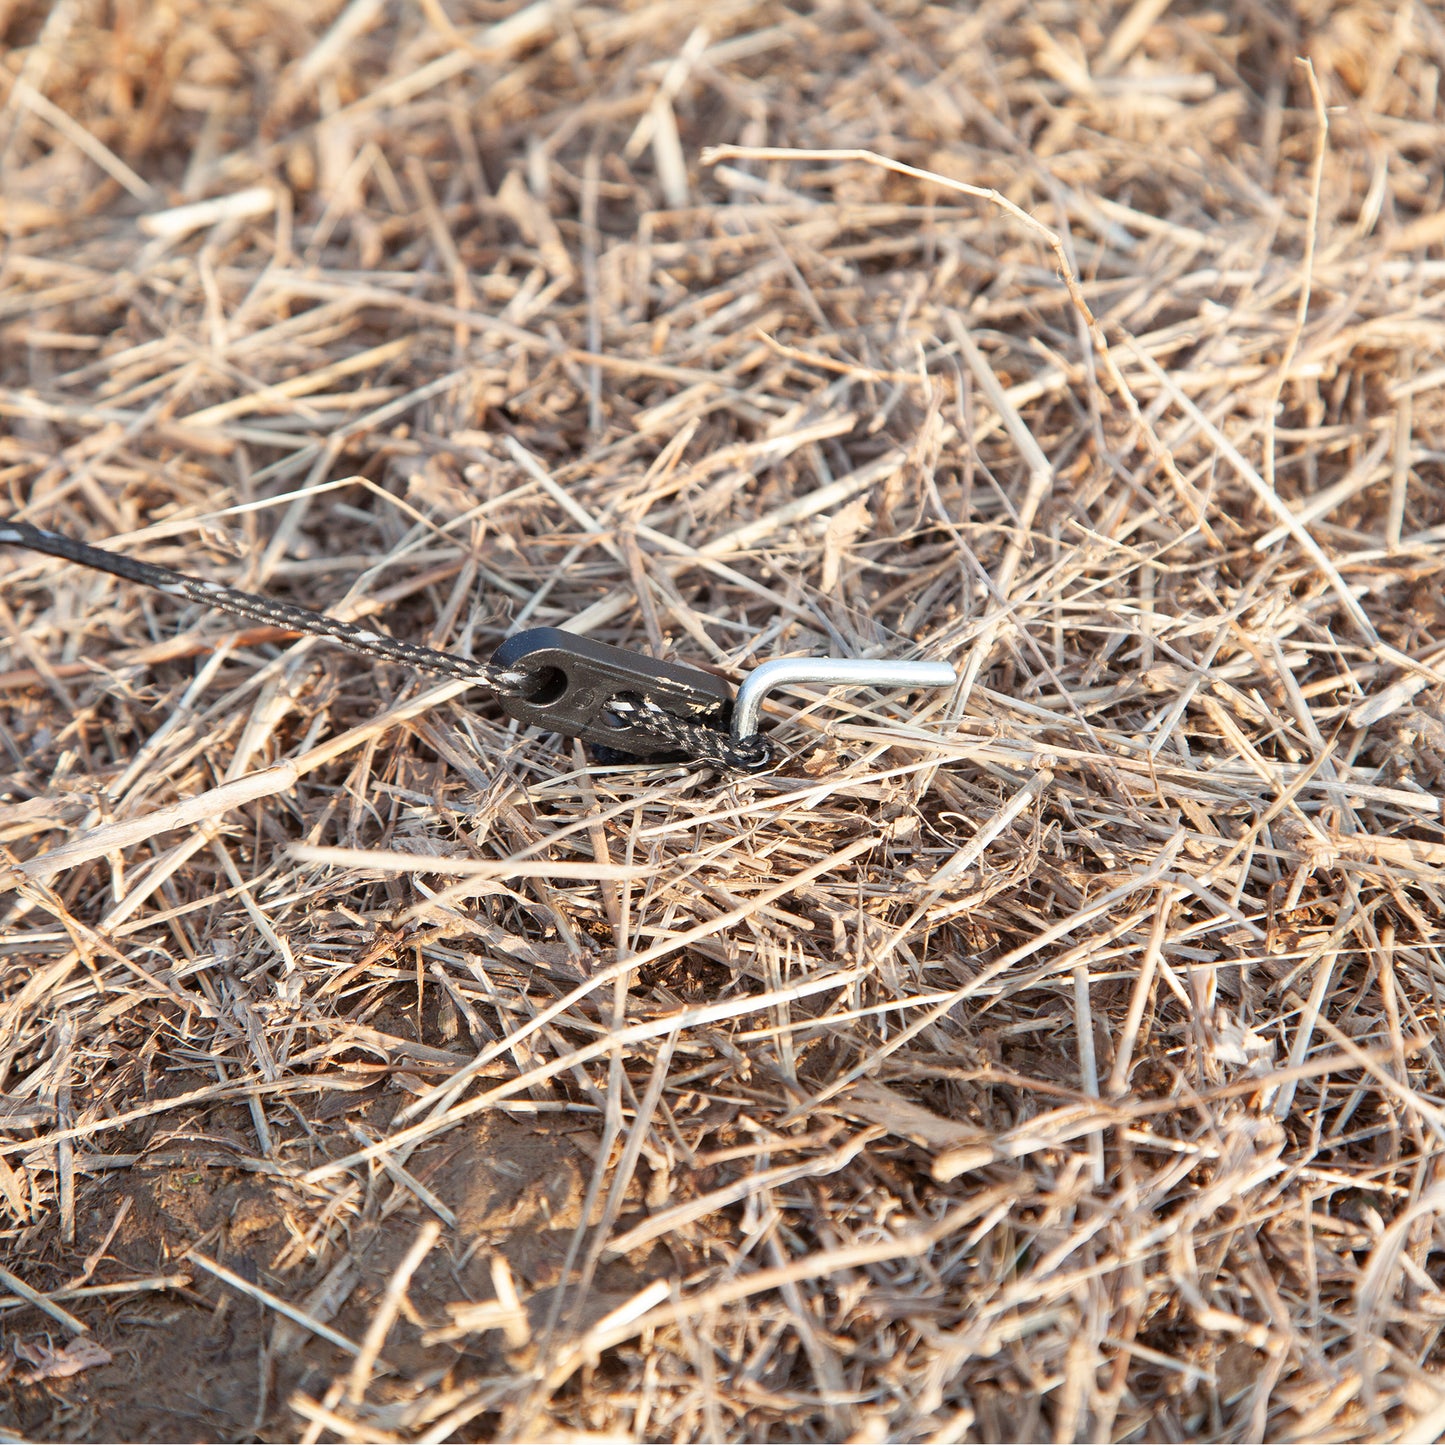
[0,522,527,696]
